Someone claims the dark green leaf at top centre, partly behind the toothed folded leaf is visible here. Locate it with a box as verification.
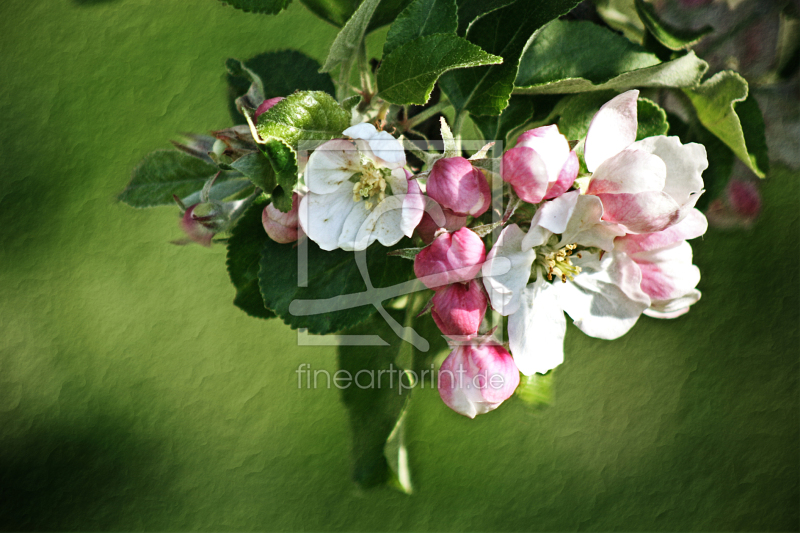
[439,0,579,115]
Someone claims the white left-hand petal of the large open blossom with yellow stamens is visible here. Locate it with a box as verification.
[482,224,536,316]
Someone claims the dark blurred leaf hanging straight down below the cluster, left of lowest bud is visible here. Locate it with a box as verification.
[337,311,411,488]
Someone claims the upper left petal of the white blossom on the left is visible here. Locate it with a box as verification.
[304,139,361,196]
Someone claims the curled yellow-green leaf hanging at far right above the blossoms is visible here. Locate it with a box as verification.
[684,70,769,178]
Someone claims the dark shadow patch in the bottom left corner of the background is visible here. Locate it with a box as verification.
[0,419,174,531]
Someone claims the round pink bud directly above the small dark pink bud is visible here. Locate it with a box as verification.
[414,228,486,289]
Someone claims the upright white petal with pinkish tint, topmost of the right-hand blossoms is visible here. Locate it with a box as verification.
[583,90,639,172]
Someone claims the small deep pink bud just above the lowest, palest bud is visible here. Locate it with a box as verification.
[431,280,487,337]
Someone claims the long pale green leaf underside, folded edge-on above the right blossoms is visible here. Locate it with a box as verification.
[514,52,708,94]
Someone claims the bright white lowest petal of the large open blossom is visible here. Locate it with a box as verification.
[508,276,567,376]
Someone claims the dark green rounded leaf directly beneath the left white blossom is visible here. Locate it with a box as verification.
[259,240,413,334]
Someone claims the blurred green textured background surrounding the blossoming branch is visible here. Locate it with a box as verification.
[0,0,800,531]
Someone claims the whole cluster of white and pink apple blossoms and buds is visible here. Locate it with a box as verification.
[250,90,708,418]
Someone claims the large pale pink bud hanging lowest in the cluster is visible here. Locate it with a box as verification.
[439,343,519,418]
